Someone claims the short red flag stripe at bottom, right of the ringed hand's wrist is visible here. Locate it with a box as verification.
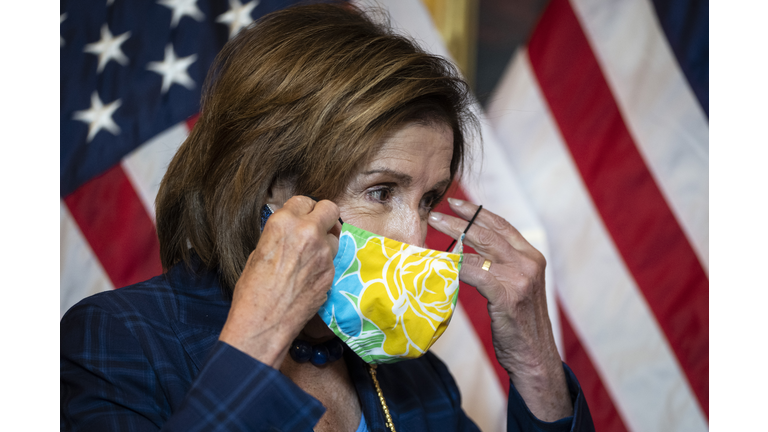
[557,304,627,432]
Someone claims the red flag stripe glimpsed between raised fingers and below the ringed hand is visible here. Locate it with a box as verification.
[427,184,509,395]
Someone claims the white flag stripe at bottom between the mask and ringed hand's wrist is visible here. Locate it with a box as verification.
[431,303,507,432]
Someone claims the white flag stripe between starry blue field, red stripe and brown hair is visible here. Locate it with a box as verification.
[120,122,189,223]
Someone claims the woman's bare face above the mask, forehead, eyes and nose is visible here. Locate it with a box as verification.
[335,123,453,247]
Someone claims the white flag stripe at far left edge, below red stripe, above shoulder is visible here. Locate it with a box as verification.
[59,201,114,317]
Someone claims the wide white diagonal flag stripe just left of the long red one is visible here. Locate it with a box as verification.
[489,49,708,432]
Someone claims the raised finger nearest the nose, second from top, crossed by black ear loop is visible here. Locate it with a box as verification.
[429,212,520,262]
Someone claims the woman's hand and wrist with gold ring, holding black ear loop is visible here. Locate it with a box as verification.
[429,198,573,421]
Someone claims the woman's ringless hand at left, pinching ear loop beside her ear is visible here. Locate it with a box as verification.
[219,196,341,369]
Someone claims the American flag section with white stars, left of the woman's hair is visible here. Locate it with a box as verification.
[60,0,306,313]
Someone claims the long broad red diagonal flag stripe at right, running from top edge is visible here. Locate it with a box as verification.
[528,0,709,416]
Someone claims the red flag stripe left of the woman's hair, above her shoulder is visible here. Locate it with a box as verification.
[64,164,162,287]
